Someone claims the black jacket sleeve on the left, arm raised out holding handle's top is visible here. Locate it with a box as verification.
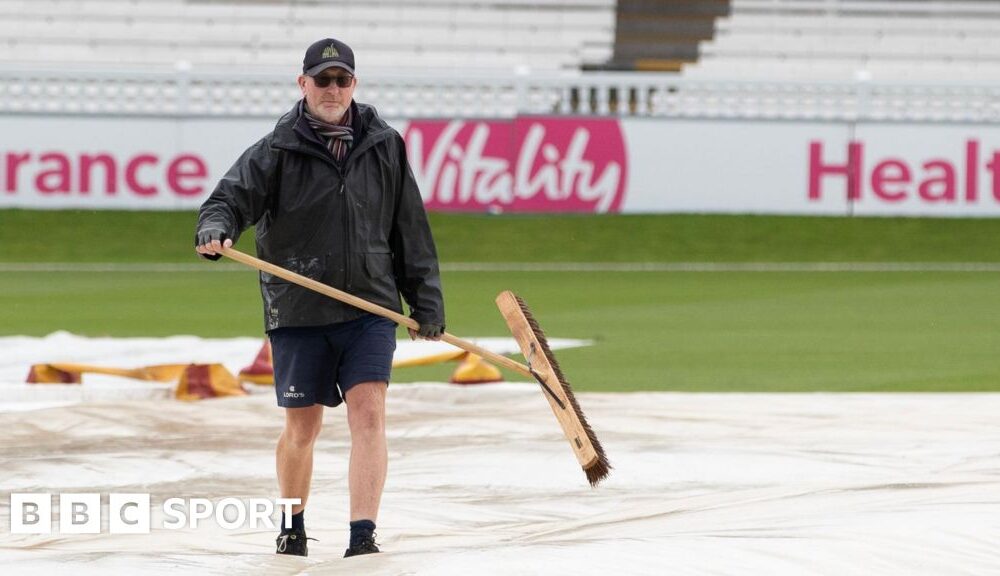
[195,138,278,250]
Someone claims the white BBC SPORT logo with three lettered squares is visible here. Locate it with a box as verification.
[10,492,302,534]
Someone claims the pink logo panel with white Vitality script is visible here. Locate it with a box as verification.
[404,118,628,213]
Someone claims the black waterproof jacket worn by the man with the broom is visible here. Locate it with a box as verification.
[198,102,444,330]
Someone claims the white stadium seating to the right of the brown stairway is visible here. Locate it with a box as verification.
[684,0,1000,82]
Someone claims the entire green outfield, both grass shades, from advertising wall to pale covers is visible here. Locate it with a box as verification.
[0,211,1000,391]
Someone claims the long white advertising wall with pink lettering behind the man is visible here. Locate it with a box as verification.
[0,115,1000,216]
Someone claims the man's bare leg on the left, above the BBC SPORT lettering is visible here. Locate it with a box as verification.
[276,404,323,514]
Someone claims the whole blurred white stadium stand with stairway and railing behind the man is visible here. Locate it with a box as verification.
[0,0,1000,122]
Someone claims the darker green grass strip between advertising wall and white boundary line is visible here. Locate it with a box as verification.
[0,210,1000,262]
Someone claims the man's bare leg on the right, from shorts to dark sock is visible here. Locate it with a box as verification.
[344,382,389,522]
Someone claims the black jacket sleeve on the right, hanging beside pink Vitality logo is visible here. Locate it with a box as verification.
[390,132,445,326]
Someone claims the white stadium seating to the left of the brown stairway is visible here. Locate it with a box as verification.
[0,0,615,72]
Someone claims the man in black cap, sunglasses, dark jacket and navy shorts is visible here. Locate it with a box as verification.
[195,38,444,557]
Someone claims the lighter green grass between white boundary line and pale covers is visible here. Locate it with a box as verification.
[0,272,1000,391]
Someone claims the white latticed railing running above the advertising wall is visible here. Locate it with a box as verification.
[0,68,1000,123]
